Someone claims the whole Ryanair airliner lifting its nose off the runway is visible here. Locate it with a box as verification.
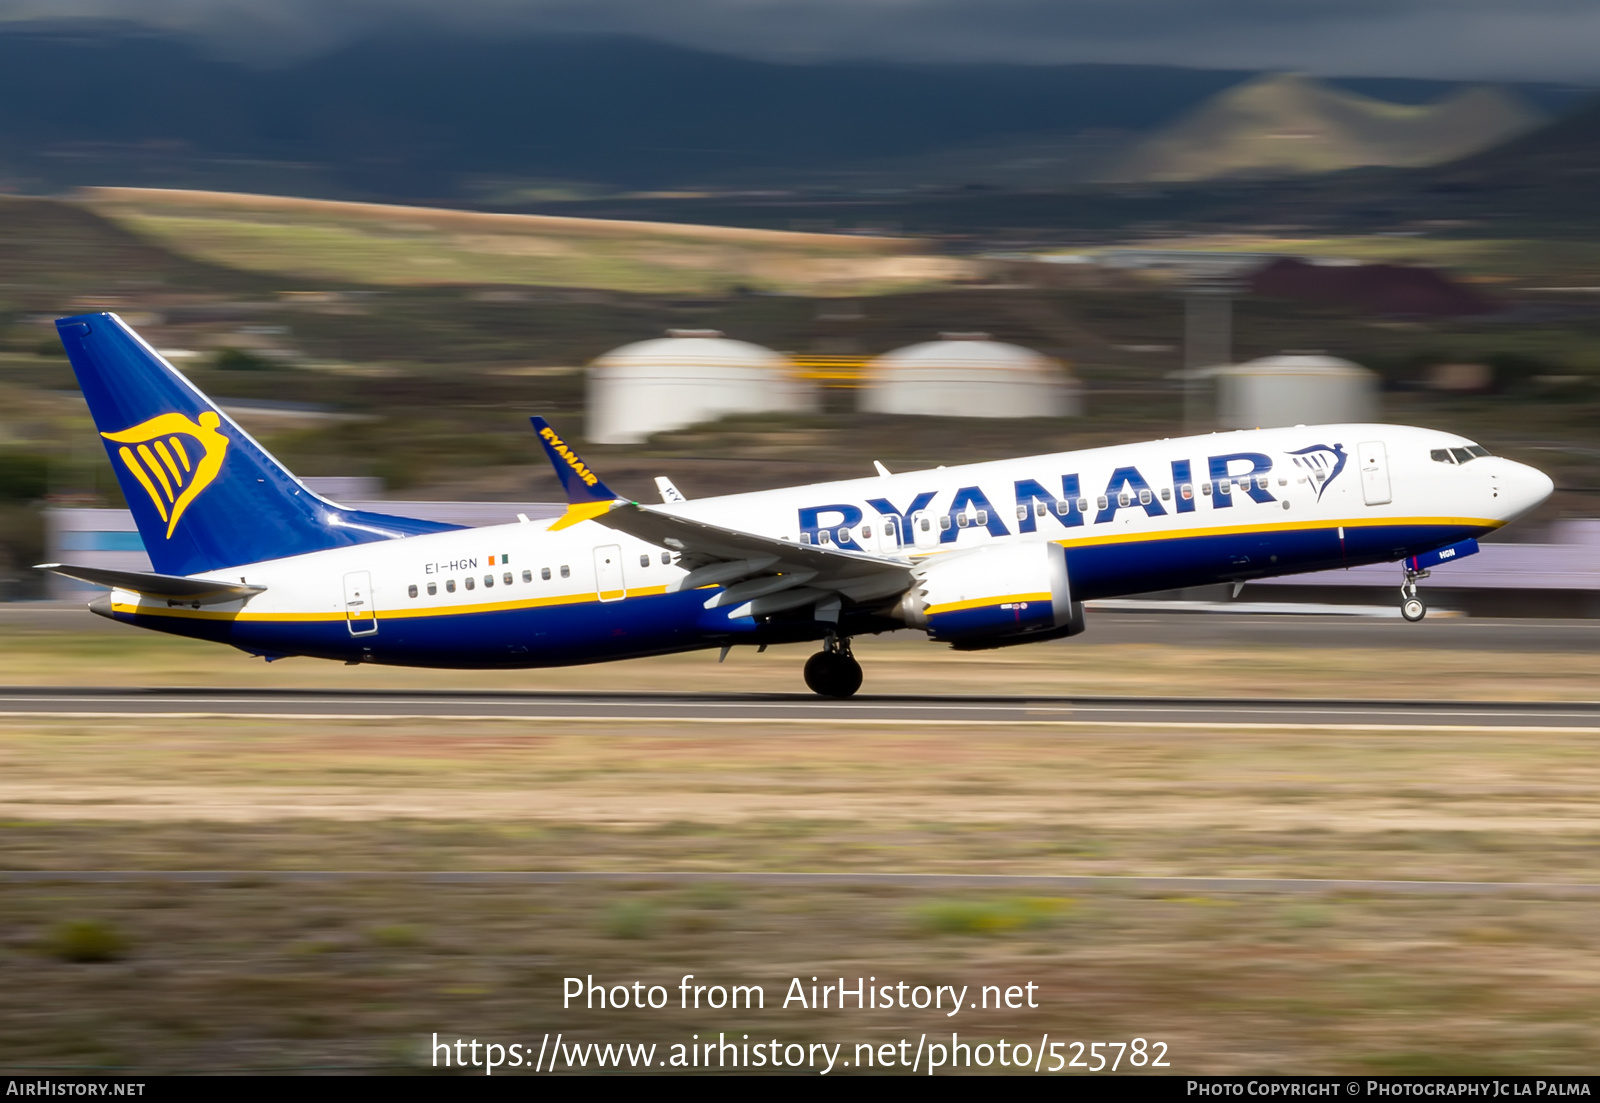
[43,314,1552,696]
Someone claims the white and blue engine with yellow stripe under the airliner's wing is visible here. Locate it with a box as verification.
[898,543,1083,648]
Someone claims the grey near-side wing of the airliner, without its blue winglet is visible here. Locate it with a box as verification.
[590,501,914,615]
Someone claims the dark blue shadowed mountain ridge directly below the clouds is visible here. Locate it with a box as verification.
[0,24,1581,200]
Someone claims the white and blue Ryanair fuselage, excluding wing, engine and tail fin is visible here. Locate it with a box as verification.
[101,424,1550,668]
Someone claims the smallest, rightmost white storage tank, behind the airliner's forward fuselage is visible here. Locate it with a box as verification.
[1211,354,1378,429]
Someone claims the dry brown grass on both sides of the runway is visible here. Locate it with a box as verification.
[0,626,1600,1074]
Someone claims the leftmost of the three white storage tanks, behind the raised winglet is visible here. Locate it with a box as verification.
[587,330,813,443]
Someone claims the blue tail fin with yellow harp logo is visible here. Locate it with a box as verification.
[56,314,458,575]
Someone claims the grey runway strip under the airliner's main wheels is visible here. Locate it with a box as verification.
[0,687,1600,733]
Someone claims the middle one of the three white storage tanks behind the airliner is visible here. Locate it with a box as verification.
[861,333,1082,418]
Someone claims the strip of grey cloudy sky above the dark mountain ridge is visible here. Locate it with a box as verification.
[0,0,1600,85]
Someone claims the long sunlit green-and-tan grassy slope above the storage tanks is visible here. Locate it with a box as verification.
[83,187,970,295]
